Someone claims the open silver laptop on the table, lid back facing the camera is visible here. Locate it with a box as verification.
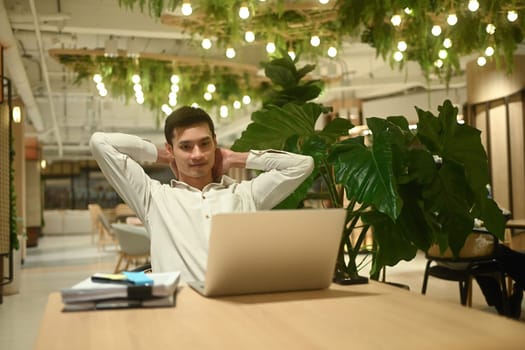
[188,209,346,297]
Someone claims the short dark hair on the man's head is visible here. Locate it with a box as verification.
[164,106,215,145]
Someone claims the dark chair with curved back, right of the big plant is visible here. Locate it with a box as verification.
[421,229,508,312]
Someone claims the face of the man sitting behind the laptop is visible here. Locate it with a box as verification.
[167,123,217,183]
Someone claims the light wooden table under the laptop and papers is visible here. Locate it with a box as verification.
[35,281,525,350]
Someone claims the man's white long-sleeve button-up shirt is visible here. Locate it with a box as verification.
[90,132,313,281]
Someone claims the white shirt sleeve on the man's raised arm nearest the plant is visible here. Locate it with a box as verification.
[246,150,314,210]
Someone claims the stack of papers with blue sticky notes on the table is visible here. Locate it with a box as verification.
[61,271,180,311]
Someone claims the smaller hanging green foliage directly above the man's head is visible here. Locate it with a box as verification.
[58,55,265,125]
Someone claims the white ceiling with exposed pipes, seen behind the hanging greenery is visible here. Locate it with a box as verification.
[0,0,498,161]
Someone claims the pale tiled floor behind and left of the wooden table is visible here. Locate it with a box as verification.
[0,235,525,350]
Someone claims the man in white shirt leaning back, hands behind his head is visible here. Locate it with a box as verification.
[90,107,313,280]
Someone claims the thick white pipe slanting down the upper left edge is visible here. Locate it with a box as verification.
[0,1,44,131]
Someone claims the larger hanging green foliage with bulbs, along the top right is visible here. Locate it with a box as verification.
[115,0,525,83]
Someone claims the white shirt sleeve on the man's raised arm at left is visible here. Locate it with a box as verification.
[89,132,157,222]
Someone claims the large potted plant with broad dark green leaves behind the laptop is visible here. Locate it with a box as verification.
[232,54,505,283]
